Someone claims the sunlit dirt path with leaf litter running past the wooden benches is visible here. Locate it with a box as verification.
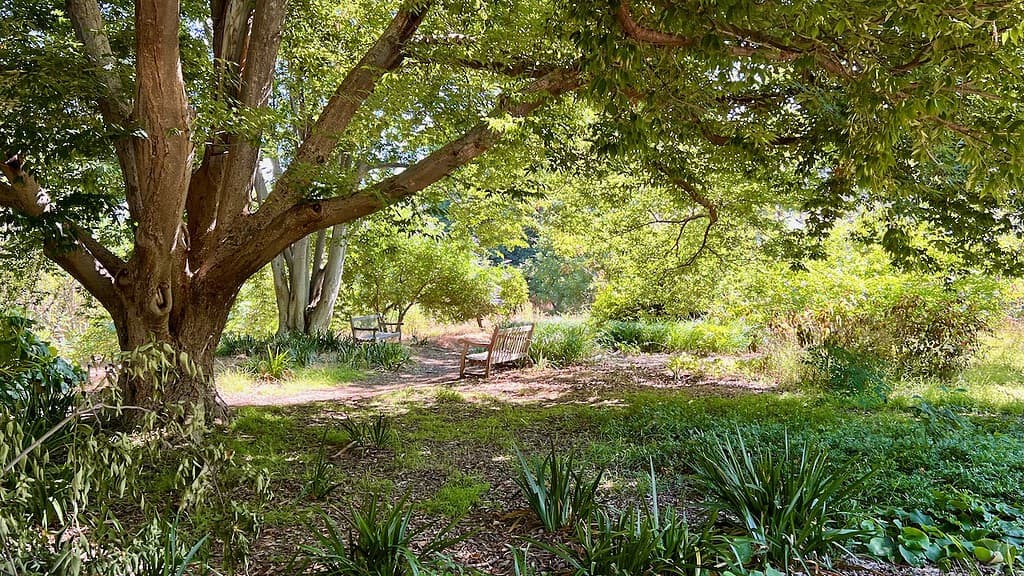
[222,341,773,406]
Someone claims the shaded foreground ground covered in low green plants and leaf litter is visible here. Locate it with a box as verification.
[4,313,1024,574]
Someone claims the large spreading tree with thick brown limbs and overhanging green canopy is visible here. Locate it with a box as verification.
[0,0,1024,407]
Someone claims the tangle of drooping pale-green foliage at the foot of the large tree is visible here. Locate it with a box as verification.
[0,319,269,576]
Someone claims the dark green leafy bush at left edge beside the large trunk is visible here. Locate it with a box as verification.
[0,316,87,429]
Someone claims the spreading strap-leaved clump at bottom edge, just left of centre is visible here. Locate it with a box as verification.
[301,495,465,576]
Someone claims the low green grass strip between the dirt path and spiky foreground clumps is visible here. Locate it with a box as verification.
[152,317,1024,565]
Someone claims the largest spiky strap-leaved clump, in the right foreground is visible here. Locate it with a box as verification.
[693,428,868,569]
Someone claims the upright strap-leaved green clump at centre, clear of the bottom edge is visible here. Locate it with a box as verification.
[515,446,604,532]
